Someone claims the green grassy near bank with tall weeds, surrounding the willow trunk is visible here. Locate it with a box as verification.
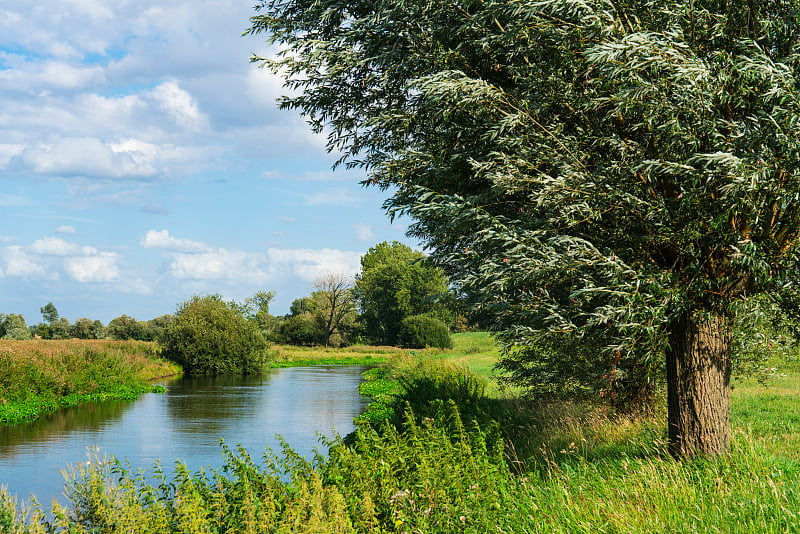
[0,333,800,533]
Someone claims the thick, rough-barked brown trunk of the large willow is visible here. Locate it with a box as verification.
[667,314,731,457]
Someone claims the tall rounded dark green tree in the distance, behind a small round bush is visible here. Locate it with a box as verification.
[353,241,452,345]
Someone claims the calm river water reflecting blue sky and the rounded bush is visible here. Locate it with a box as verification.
[0,366,368,510]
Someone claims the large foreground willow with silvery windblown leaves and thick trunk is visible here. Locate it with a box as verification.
[250,0,800,456]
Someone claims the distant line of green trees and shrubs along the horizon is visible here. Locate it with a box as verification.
[0,241,468,347]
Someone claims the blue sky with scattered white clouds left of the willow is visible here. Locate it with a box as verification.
[0,0,415,324]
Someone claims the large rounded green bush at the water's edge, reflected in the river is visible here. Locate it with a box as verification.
[161,295,267,375]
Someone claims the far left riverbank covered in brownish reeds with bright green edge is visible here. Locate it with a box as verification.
[0,339,181,425]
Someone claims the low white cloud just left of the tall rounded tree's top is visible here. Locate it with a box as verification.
[267,248,361,282]
